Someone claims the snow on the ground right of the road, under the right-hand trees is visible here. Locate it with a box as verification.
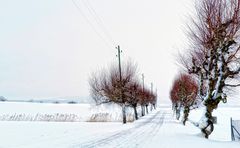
[150,108,240,148]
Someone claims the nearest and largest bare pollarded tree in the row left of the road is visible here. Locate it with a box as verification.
[89,62,137,123]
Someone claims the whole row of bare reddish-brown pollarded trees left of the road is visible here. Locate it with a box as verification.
[89,61,157,123]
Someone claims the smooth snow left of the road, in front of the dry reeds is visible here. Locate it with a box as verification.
[0,121,131,148]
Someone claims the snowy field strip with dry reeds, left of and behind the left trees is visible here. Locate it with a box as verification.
[0,102,137,122]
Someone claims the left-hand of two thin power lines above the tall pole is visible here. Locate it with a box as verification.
[72,0,112,48]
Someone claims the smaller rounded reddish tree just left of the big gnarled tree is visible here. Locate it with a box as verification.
[170,74,198,125]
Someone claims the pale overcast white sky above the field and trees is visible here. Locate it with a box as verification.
[0,0,195,100]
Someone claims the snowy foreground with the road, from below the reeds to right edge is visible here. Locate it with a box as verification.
[0,108,240,148]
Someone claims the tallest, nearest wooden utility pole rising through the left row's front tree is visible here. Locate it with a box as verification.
[116,45,127,124]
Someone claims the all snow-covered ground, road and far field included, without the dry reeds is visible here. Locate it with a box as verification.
[0,102,240,148]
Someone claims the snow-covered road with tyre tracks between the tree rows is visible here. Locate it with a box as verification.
[73,111,166,148]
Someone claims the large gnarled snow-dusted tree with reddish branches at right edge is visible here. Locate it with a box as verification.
[171,0,240,138]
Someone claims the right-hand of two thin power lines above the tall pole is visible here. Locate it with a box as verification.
[82,0,115,45]
